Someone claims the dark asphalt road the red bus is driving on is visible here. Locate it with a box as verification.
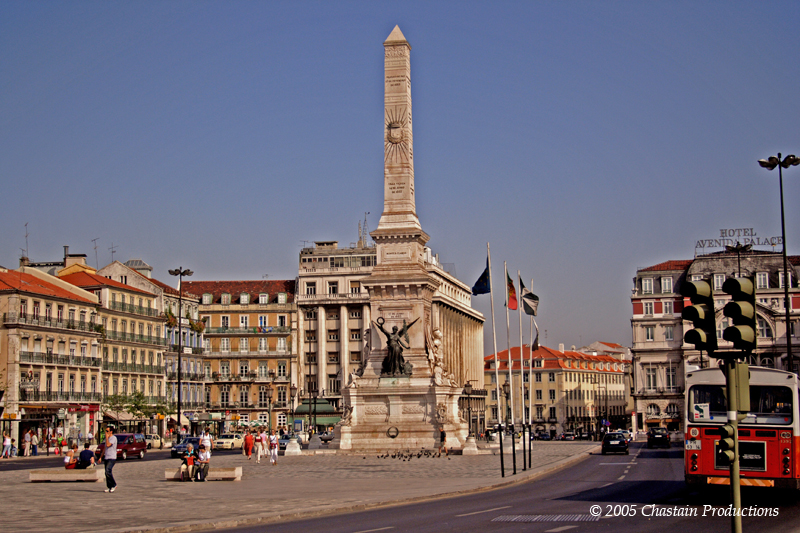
[208,443,800,533]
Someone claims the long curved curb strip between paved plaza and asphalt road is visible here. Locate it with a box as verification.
[108,445,600,533]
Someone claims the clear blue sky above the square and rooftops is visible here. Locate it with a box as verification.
[0,1,800,348]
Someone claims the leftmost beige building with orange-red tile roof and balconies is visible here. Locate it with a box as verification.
[0,267,102,444]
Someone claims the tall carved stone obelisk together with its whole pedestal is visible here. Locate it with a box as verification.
[335,26,466,450]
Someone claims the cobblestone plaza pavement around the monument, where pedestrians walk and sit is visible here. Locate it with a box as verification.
[0,442,597,533]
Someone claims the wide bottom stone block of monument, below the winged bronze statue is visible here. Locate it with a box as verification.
[335,376,468,452]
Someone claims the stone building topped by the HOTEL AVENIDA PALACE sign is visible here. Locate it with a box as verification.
[631,249,800,430]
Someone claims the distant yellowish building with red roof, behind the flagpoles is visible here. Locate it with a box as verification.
[484,345,627,436]
